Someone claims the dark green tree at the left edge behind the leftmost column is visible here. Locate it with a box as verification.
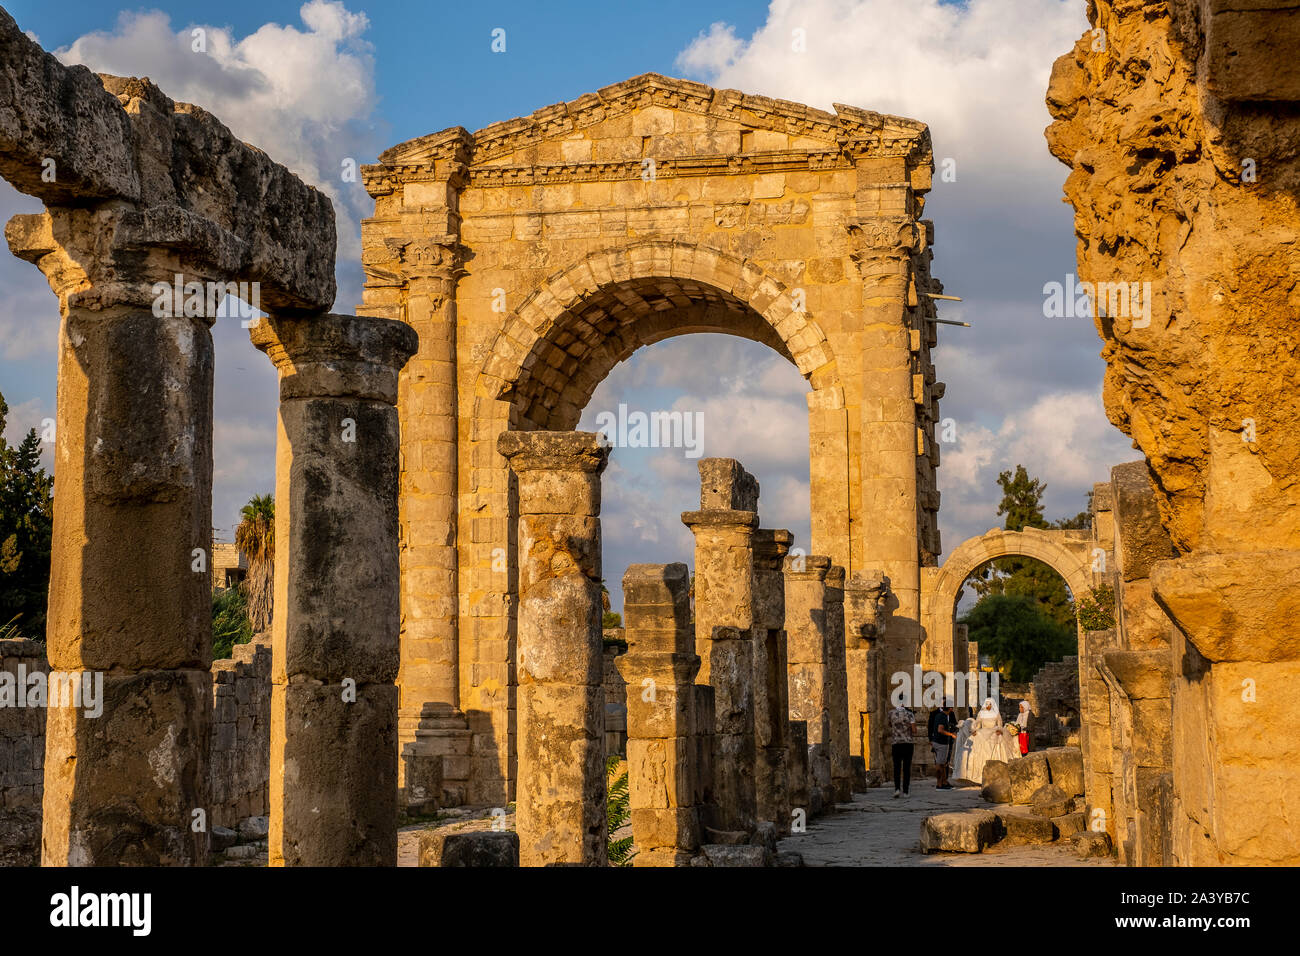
[0,395,55,640]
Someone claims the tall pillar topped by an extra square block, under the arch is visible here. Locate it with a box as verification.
[681,458,758,830]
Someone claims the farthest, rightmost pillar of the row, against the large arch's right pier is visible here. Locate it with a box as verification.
[844,571,891,771]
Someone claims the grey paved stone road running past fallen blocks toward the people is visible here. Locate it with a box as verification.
[780,779,1115,866]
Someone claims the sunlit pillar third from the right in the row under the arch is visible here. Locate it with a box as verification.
[785,554,835,814]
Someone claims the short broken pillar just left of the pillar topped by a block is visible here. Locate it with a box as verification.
[616,564,699,866]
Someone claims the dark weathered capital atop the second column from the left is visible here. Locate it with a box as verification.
[248,313,420,405]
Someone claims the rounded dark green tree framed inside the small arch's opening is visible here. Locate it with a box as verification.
[962,594,1079,683]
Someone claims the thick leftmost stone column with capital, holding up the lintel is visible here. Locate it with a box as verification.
[5,207,213,866]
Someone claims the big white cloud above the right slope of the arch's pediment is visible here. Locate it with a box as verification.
[677,0,1087,189]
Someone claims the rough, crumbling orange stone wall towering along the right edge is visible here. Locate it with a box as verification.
[1047,0,1300,865]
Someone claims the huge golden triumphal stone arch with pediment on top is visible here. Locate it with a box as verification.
[358,74,943,803]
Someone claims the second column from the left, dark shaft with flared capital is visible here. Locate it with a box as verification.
[250,315,416,866]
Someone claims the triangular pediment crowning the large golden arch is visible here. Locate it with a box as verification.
[380,73,930,166]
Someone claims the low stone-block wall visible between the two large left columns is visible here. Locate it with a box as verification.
[208,643,270,830]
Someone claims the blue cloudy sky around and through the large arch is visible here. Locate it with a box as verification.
[0,0,1138,604]
